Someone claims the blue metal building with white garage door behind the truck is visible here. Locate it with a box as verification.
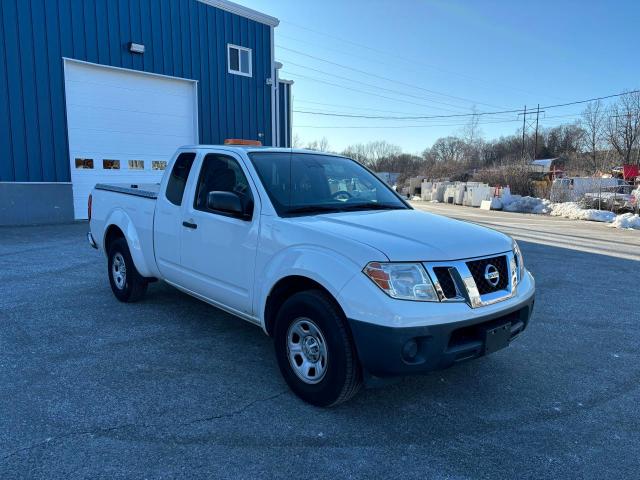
[0,0,291,225]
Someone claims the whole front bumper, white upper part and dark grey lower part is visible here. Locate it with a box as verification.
[340,272,535,377]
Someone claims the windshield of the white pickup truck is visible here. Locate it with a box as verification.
[249,152,408,215]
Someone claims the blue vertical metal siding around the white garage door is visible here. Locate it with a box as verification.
[0,0,271,182]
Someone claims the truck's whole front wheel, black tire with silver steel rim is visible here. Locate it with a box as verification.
[274,290,362,407]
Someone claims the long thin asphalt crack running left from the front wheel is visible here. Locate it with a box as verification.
[0,389,289,464]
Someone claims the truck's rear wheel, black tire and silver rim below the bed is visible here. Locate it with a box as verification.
[107,238,149,302]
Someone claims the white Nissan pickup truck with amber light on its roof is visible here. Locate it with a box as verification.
[88,145,535,406]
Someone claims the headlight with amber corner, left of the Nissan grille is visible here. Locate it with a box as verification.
[363,262,438,302]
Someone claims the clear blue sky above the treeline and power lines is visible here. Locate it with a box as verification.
[244,0,640,152]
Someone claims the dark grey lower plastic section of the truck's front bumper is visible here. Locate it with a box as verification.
[349,296,534,377]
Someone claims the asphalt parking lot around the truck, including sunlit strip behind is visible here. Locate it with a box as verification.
[0,215,640,479]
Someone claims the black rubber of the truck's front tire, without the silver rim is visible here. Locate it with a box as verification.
[274,292,351,406]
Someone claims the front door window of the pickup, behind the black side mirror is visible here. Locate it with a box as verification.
[193,153,253,215]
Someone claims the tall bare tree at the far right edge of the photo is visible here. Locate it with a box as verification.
[607,92,640,164]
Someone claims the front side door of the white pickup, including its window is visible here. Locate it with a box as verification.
[180,153,260,315]
